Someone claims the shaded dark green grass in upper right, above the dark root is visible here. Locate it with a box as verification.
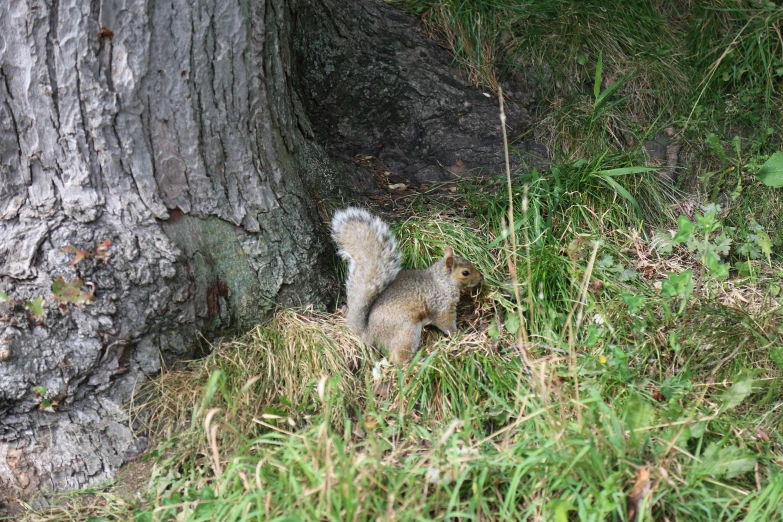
[393,0,783,181]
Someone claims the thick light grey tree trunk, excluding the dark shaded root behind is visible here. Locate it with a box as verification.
[0,0,335,500]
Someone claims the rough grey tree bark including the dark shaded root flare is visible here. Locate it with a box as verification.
[0,0,540,504]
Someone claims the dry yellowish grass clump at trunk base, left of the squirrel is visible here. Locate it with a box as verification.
[138,310,378,468]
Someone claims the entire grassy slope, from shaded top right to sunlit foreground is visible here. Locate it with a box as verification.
[16,0,783,521]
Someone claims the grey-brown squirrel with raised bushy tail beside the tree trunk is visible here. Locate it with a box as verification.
[332,207,483,364]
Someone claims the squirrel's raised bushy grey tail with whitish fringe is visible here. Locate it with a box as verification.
[332,207,402,332]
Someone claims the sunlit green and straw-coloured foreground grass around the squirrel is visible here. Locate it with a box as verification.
[19,164,783,521]
